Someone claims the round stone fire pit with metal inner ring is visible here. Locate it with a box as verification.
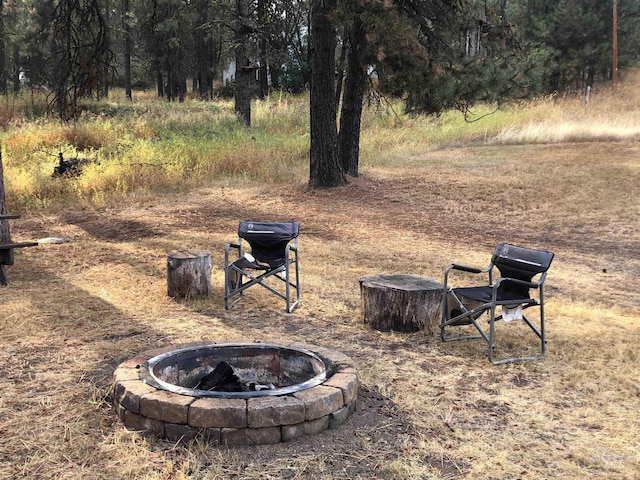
[113,341,358,445]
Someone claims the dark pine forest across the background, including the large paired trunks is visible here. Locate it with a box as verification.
[0,0,640,187]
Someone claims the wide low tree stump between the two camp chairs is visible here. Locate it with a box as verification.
[360,274,444,335]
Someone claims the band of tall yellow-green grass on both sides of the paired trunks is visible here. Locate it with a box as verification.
[0,71,640,210]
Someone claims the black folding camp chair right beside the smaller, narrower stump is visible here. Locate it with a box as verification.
[224,221,300,313]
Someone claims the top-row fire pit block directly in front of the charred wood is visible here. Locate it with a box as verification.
[188,398,247,428]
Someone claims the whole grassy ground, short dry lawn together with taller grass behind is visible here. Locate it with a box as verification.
[0,76,640,480]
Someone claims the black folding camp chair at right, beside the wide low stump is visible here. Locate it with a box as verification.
[440,243,553,365]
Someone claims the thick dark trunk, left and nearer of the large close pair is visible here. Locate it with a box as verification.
[309,0,346,188]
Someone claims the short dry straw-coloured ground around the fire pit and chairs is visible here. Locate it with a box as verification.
[0,143,640,479]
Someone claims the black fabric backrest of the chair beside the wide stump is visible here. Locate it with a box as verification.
[491,243,554,297]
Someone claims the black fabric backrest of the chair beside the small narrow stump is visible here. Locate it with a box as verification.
[238,220,299,267]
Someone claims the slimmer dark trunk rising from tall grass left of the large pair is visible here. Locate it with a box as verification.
[235,0,253,126]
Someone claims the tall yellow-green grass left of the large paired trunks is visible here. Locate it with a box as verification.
[0,95,308,210]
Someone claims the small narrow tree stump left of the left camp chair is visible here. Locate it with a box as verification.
[167,250,212,298]
